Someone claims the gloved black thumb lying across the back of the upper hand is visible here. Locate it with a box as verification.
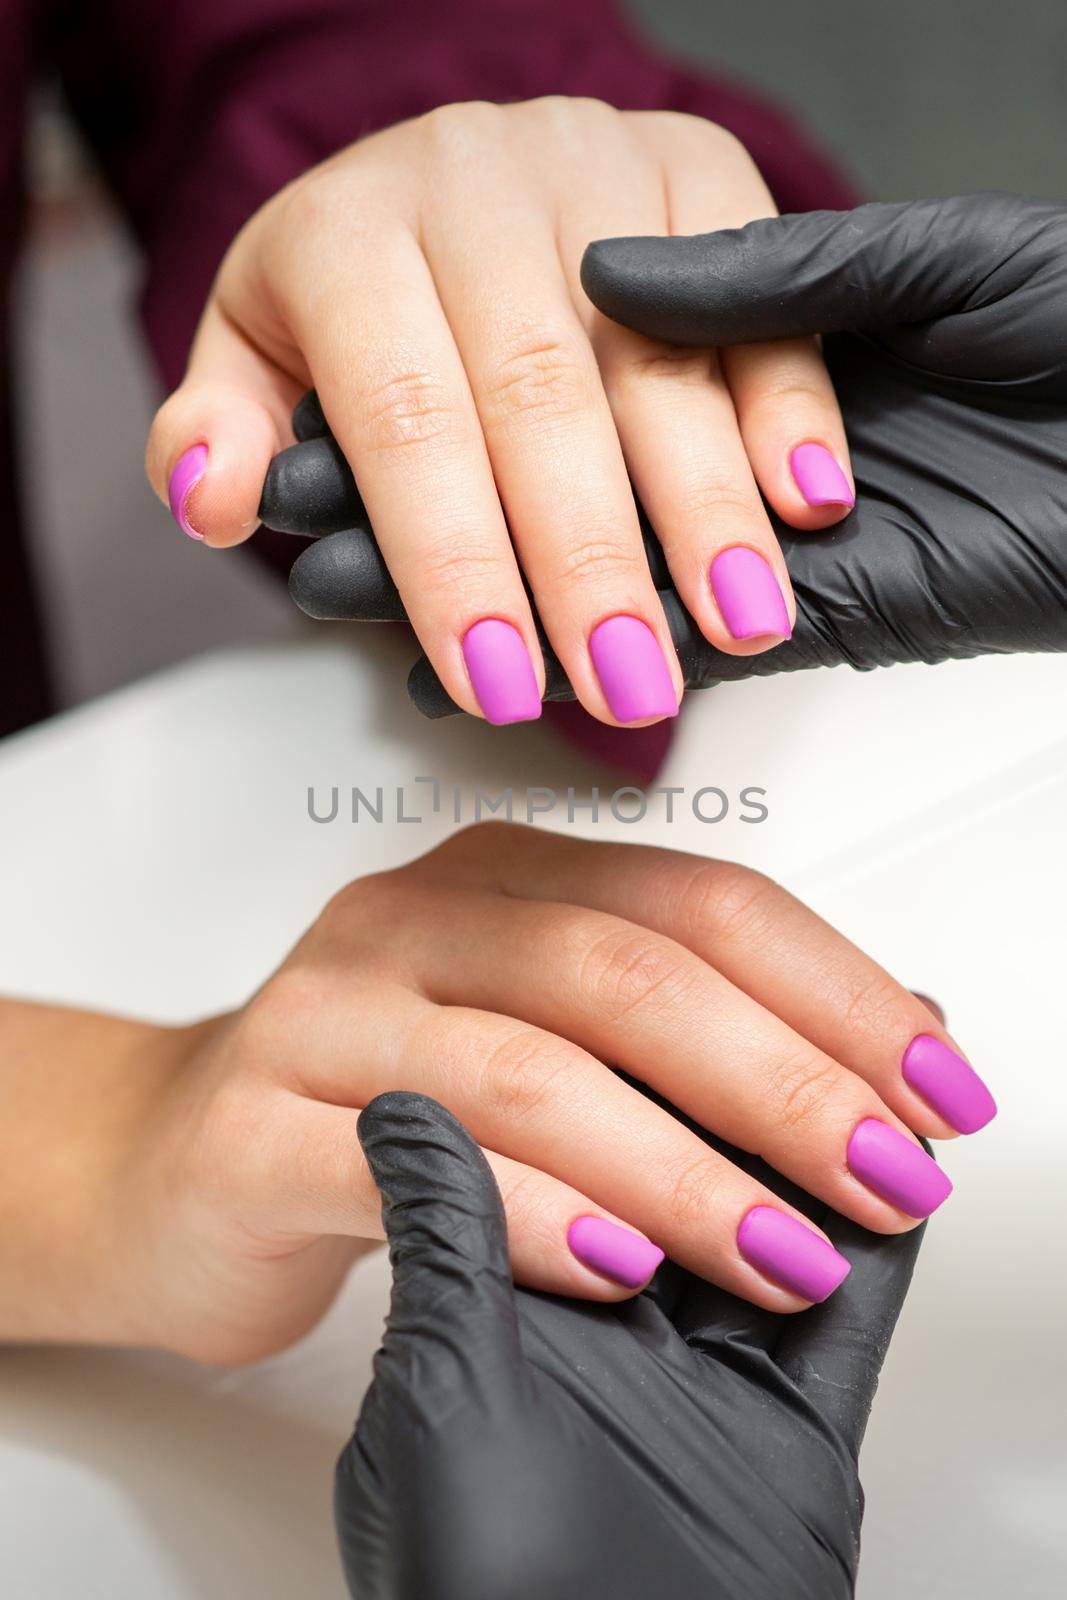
[582,194,1056,346]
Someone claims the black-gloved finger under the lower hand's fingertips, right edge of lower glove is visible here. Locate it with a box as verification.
[776,1216,925,1456]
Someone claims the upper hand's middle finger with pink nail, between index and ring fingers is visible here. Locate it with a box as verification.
[419,116,681,725]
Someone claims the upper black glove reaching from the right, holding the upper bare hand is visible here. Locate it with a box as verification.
[262,194,1067,717]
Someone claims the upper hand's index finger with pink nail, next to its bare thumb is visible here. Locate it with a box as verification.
[281,230,542,722]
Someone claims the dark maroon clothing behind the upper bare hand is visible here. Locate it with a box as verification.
[0,0,854,745]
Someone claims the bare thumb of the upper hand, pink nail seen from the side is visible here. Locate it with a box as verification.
[146,301,299,547]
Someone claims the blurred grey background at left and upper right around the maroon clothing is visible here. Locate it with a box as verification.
[16,0,1067,704]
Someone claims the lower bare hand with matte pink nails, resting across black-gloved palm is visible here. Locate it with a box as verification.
[79,824,995,1362]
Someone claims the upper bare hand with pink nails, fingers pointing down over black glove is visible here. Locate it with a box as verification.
[147,98,853,725]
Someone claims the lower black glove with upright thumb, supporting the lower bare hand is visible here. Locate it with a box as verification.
[334,1093,921,1600]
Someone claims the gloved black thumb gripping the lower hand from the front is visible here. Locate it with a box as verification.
[358,1090,522,1388]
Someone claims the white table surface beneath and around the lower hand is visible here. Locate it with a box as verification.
[0,630,1067,1600]
